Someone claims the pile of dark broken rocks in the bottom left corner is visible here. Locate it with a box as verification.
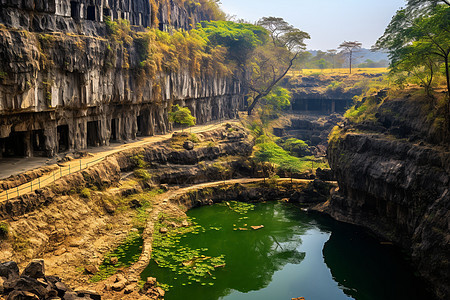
[0,260,101,300]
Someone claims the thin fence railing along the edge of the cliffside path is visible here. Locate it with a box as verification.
[0,157,105,201]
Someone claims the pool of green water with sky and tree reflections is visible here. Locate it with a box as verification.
[142,202,431,300]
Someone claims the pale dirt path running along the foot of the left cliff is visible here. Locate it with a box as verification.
[0,120,239,201]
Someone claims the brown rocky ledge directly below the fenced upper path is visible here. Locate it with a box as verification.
[0,126,253,219]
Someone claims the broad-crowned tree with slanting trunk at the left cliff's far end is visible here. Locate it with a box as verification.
[197,17,310,115]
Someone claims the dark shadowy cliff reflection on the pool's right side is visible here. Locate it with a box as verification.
[322,220,431,300]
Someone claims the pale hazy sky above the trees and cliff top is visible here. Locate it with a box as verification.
[221,0,406,50]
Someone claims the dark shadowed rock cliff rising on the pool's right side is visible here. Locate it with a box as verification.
[326,99,450,299]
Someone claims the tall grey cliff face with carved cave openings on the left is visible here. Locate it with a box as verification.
[0,0,243,157]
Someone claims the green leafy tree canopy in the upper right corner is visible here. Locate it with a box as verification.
[376,1,450,97]
